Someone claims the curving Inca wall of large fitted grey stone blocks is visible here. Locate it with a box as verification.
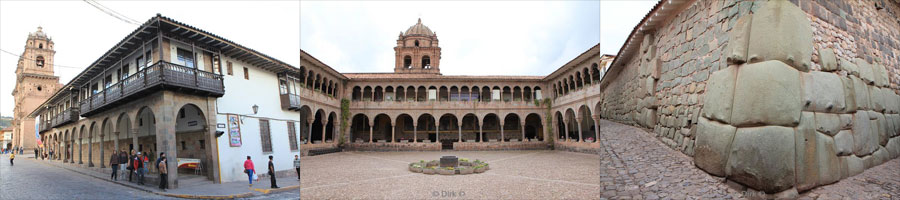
[601,0,900,195]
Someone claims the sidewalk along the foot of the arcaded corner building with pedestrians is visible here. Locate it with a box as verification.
[38,160,300,199]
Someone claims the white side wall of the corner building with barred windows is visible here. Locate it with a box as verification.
[216,57,300,182]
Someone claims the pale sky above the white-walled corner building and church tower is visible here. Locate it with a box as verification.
[0,1,300,116]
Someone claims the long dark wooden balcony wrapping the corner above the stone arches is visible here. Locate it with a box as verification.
[79,61,225,117]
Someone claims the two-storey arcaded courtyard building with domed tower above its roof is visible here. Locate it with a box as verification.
[298,19,613,155]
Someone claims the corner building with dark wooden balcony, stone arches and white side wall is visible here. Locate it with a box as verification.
[29,15,302,188]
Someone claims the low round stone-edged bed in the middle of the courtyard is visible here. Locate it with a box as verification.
[409,158,490,175]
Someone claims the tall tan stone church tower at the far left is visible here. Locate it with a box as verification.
[12,27,62,152]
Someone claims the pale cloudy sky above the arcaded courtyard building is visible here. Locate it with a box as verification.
[300,1,600,75]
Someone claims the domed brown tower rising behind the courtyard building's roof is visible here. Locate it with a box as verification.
[394,18,441,74]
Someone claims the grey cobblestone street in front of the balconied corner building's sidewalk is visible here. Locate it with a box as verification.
[0,154,174,199]
